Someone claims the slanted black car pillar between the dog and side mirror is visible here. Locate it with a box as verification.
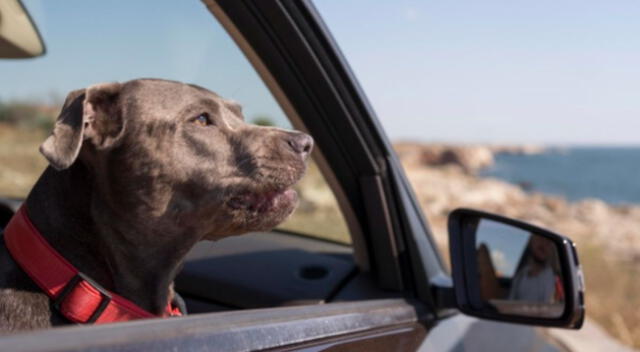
[204,0,448,307]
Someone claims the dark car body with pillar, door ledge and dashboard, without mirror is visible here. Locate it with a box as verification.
[0,0,570,351]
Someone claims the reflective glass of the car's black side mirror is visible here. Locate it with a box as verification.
[473,219,565,318]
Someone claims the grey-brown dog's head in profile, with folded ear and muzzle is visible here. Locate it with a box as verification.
[40,79,313,239]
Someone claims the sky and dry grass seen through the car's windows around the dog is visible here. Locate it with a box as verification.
[0,0,351,243]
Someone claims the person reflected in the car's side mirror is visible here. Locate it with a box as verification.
[508,234,563,303]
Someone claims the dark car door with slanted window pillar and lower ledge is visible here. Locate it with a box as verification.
[2,0,568,351]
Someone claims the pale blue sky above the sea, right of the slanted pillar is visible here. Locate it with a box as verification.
[317,0,640,144]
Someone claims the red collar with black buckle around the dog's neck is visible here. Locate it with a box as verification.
[4,206,181,324]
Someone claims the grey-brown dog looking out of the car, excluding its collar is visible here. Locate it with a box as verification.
[0,79,313,333]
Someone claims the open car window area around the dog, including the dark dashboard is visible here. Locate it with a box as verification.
[0,0,356,320]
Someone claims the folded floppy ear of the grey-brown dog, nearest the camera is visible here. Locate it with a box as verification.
[40,83,124,170]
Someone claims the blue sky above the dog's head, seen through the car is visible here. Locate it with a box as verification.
[0,0,286,128]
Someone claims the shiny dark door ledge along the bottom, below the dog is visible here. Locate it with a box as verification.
[1,299,425,352]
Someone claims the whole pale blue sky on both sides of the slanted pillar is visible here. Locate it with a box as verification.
[0,0,640,145]
